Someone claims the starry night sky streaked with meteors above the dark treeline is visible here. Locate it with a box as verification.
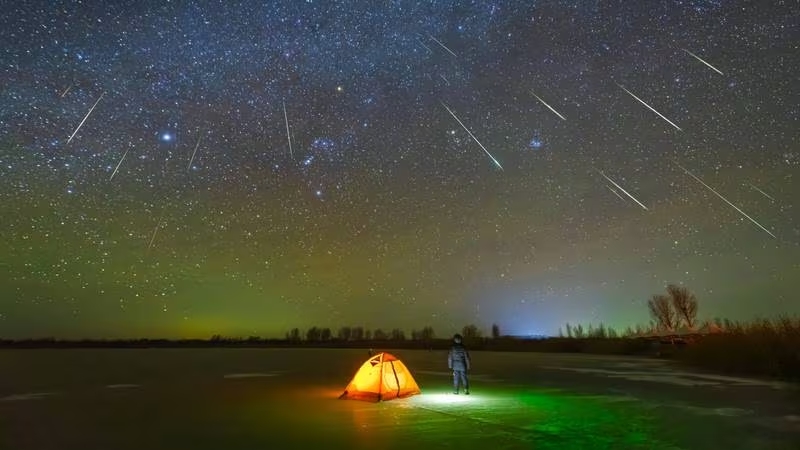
[0,0,800,338]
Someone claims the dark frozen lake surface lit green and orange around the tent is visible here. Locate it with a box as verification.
[0,349,800,450]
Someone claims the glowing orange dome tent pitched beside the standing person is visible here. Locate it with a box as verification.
[339,353,420,402]
